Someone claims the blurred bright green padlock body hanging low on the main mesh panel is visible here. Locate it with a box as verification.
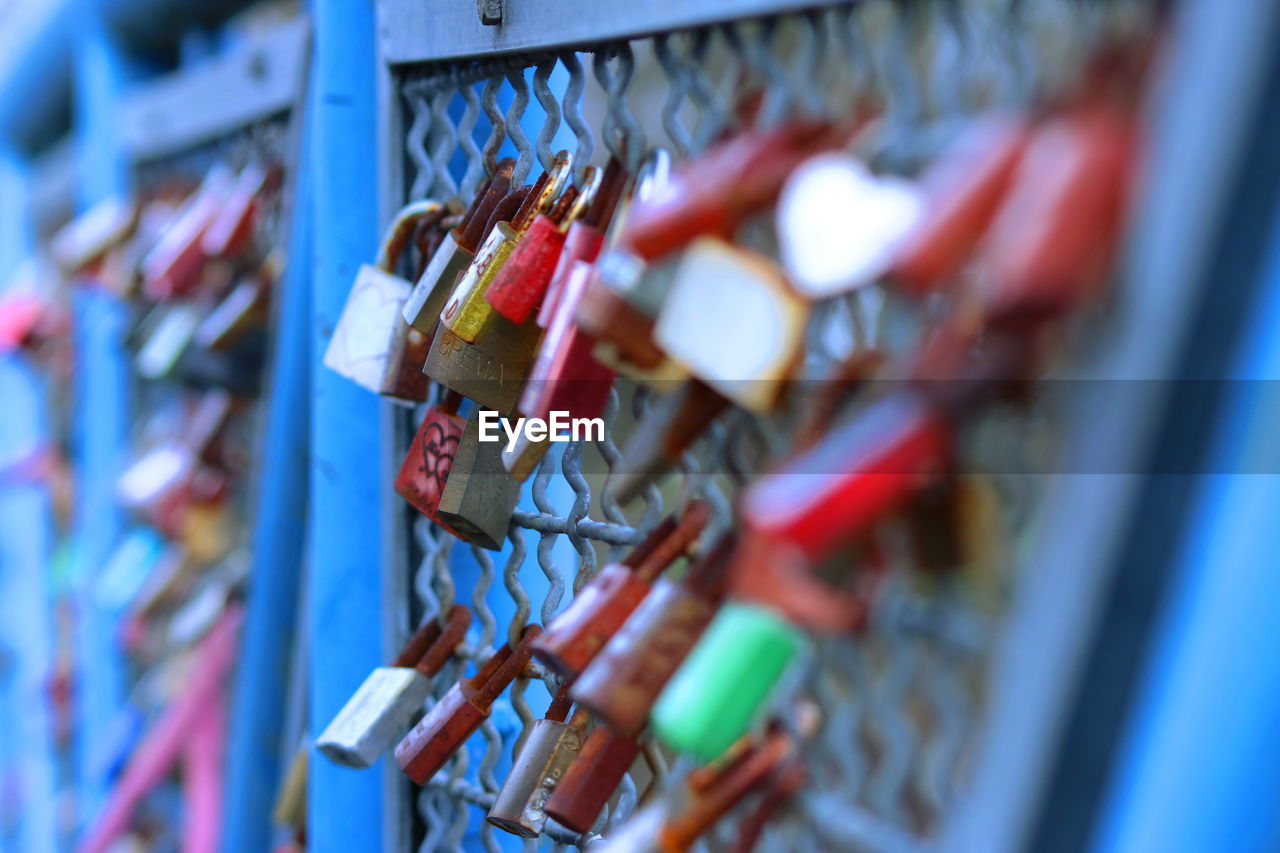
[650,602,805,762]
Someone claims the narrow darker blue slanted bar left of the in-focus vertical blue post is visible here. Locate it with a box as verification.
[223,116,311,853]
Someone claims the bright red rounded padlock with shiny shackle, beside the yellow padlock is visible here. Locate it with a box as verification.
[484,167,603,324]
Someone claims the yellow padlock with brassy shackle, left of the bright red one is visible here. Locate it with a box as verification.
[440,151,573,343]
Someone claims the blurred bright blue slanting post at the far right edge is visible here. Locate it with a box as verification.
[1094,197,1280,853]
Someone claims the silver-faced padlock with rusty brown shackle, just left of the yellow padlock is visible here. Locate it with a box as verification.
[403,158,516,334]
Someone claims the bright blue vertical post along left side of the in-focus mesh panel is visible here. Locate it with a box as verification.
[307,0,385,853]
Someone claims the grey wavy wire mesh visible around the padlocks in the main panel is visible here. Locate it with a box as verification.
[386,0,1144,853]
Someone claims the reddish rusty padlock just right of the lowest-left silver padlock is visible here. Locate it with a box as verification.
[396,625,541,785]
